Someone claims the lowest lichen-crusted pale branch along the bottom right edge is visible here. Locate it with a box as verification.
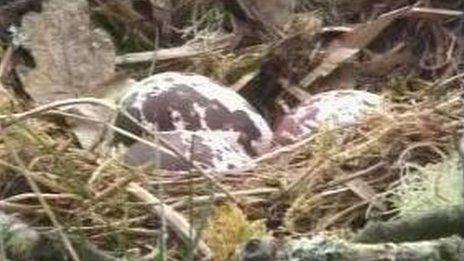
[237,236,464,261]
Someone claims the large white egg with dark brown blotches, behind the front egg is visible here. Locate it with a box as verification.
[115,72,273,155]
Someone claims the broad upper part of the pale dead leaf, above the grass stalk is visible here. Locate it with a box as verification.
[21,0,115,103]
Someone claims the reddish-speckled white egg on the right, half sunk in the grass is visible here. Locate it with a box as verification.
[275,90,383,142]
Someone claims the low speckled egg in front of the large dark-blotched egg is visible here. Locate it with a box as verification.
[123,130,254,172]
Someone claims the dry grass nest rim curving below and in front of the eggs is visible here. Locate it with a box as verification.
[0,86,462,253]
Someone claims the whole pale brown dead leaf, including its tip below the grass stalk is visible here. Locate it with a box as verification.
[18,0,131,149]
